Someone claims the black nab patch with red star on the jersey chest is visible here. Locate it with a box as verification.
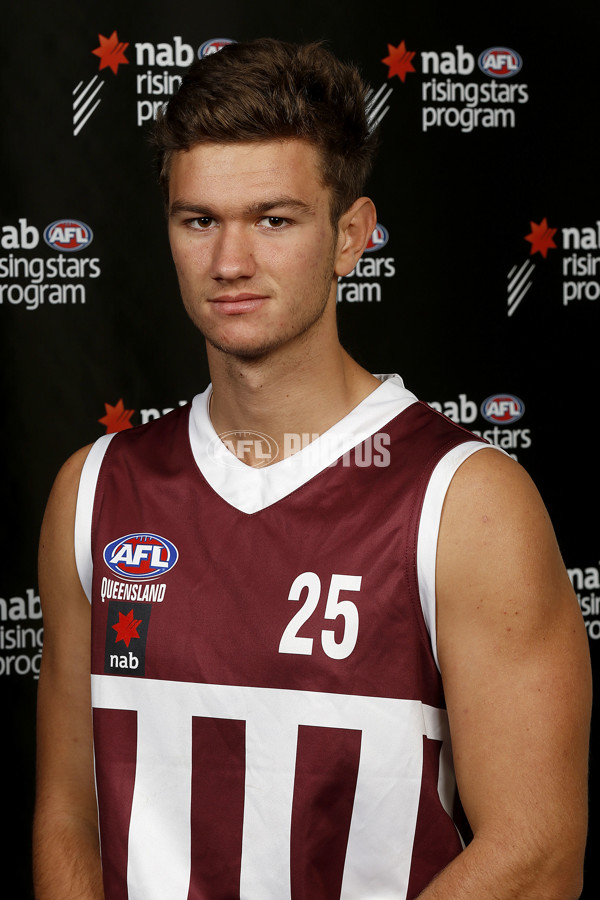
[104,600,152,676]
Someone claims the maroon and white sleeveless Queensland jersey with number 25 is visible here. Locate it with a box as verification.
[76,376,485,900]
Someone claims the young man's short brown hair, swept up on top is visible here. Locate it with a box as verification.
[153,38,376,223]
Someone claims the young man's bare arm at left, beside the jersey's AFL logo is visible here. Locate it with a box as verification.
[33,448,104,900]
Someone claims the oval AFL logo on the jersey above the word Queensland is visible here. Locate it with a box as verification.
[104,533,179,581]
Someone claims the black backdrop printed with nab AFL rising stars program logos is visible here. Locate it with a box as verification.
[0,0,600,898]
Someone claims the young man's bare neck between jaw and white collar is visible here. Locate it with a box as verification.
[208,320,379,468]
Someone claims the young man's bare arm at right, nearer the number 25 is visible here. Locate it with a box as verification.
[420,450,591,900]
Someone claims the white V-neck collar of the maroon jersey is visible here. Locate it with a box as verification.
[189,375,417,514]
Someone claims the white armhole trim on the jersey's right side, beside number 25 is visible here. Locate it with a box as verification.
[417,441,504,669]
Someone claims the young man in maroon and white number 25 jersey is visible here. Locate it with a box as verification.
[35,40,590,900]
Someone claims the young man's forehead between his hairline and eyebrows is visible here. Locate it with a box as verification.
[169,139,329,205]
